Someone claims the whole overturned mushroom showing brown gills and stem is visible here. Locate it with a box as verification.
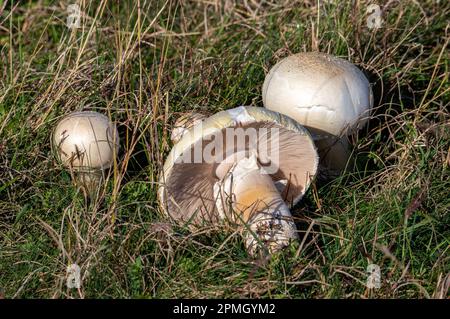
[158,106,318,256]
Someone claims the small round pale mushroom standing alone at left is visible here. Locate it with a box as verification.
[52,111,119,197]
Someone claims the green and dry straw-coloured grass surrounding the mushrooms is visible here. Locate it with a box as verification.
[0,0,450,298]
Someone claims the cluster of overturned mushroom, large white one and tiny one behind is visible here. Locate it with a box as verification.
[162,52,373,256]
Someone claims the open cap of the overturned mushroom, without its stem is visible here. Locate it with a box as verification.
[158,107,318,225]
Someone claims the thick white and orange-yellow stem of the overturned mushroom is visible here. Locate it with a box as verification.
[217,155,298,256]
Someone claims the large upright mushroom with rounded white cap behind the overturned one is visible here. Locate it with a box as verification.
[262,52,373,176]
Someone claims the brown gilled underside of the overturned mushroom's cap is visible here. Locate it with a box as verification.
[162,121,317,227]
